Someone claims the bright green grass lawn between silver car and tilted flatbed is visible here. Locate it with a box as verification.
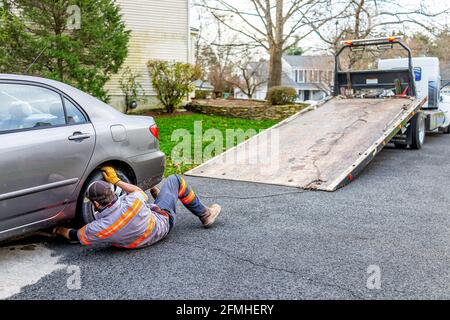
[155,114,277,176]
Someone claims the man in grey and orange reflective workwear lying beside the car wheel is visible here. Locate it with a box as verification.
[54,167,221,249]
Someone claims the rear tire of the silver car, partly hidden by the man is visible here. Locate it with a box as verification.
[76,168,131,227]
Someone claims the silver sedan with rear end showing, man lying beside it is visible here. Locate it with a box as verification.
[0,74,165,241]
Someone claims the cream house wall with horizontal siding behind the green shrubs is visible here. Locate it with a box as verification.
[106,0,196,109]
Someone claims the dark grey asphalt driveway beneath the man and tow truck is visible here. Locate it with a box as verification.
[2,135,450,299]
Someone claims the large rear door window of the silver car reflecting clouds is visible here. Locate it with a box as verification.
[0,83,66,133]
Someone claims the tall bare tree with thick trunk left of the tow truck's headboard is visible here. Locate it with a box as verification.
[198,0,345,88]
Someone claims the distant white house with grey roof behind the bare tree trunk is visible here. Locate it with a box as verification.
[235,55,334,102]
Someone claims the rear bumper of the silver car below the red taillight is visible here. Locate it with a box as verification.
[128,151,166,190]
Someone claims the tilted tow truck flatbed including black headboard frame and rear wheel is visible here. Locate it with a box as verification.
[187,38,442,191]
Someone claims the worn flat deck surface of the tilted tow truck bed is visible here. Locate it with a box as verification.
[187,97,424,191]
